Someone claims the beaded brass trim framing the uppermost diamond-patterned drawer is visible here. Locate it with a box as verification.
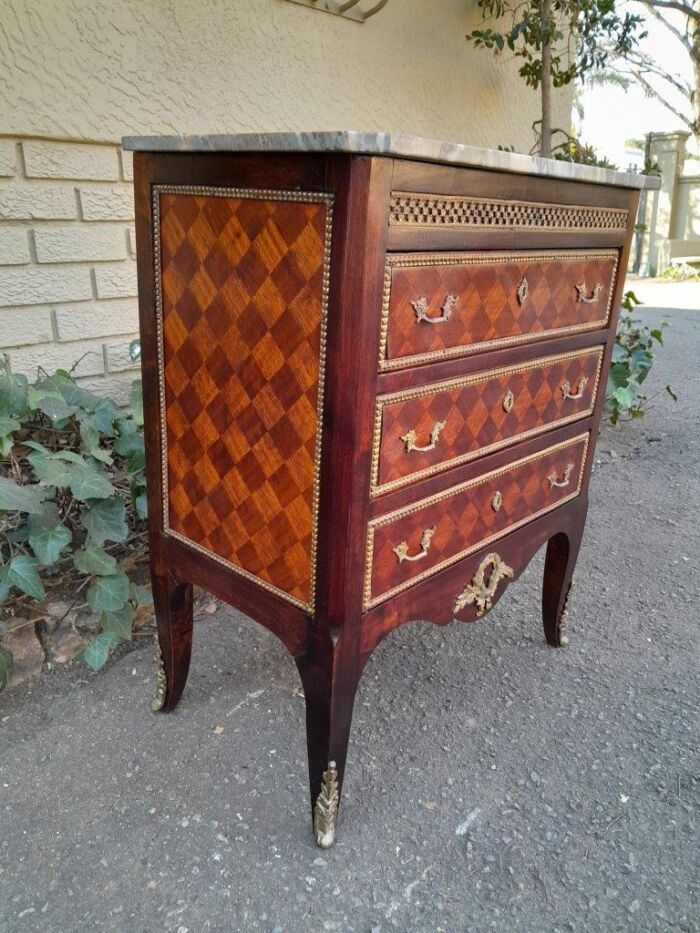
[379,249,619,372]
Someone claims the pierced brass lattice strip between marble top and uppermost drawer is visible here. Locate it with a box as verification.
[389,191,629,233]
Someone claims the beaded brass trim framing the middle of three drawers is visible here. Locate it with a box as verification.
[369,346,605,499]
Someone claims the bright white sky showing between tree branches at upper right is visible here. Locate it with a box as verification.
[576,3,692,168]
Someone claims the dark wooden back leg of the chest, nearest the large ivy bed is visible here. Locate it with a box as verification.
[151,573,193,712]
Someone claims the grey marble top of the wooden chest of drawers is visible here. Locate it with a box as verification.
[122,130,661,188]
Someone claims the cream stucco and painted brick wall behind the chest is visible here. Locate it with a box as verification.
[0,0,570,391]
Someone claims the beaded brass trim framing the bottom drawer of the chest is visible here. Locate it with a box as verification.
[363,432,590,611]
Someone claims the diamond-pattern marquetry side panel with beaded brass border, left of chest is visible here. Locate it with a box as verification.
[156,187,330,607]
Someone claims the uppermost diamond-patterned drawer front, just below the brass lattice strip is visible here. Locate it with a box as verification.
[379,249,618,370]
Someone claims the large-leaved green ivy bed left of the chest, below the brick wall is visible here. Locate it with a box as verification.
[0,362,150,691]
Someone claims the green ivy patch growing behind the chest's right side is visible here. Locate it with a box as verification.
[606,291,677,424]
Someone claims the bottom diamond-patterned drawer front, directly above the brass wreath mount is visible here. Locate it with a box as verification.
[364,434,589,609]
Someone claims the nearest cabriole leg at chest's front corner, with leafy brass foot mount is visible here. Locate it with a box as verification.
[296,635,361,849]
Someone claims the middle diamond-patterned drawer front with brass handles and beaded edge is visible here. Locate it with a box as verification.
[370,346,605,496]
